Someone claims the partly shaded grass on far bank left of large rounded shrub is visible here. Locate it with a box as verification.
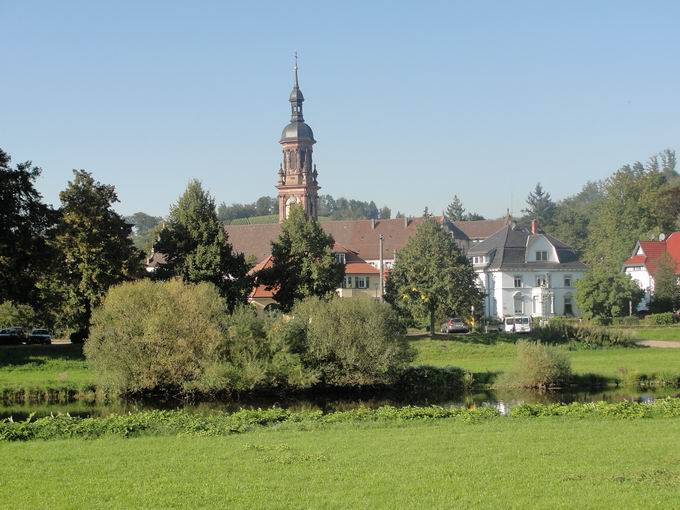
[0,344,93,389]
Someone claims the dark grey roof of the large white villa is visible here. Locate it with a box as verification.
[467,224,587,271]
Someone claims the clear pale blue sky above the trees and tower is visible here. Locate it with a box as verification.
[0,0,680,217]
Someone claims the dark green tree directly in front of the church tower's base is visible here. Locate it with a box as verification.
[257,206,344,311]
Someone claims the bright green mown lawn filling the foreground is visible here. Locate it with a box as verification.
[0,418,680,509]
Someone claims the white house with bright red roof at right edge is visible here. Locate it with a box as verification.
[623,232,680,310]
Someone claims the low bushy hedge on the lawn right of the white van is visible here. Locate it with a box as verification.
[531,319,634,347]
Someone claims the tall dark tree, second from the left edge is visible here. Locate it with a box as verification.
[53,170,142,329]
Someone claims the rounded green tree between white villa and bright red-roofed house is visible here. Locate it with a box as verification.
[576,269,644,319]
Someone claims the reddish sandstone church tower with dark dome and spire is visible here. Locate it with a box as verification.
[276,53,320,222]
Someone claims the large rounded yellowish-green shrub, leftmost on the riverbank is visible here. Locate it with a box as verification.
[85,280,232,394]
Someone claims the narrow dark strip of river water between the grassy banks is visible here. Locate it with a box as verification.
[0,388,680,420]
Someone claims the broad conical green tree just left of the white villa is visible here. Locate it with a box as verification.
[385,218,482,333]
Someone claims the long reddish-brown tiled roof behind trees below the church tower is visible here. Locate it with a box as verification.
[225,217,505,260]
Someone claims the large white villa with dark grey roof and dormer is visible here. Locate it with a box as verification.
[467,222,587,318]
